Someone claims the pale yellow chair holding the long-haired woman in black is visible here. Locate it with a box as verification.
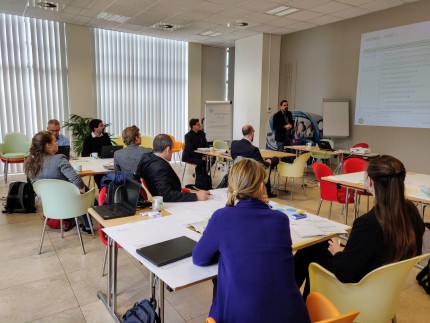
[309,254,430,323]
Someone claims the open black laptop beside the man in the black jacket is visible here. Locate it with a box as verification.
[94,178,140,220]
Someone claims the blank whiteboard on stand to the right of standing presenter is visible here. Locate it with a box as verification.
[323,99,349,137]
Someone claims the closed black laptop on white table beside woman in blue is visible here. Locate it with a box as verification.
[136,236,197,267]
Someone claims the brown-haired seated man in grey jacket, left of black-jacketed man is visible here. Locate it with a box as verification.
[113,126,152,174]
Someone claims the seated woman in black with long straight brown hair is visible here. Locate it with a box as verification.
[294,156,424,299]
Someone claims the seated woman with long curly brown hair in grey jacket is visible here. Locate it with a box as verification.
[24,131,91,233]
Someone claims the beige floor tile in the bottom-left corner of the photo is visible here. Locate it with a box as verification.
[0,275,78,322]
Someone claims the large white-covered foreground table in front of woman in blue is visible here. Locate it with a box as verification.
[88,189,350,322]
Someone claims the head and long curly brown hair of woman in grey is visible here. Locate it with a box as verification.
[24,131,58,178]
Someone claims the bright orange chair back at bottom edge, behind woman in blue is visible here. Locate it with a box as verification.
[306,292,360,323]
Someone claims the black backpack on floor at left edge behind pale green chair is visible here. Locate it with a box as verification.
[3,181,36,213]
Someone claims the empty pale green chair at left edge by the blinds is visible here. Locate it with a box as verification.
[0,132,30,183]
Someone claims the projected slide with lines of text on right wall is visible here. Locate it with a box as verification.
[354,22,430,128]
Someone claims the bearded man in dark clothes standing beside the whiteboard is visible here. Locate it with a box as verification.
[273,100,294,151]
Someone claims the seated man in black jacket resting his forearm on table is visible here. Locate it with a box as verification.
[136,134,209,202]
